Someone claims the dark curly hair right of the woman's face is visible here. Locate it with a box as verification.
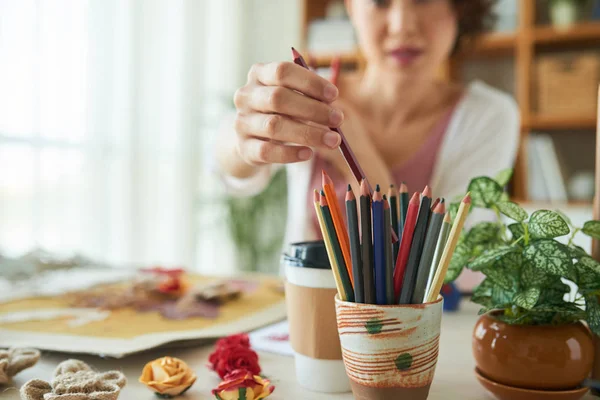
[452,0,496,53]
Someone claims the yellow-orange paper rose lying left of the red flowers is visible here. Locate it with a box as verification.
[139,357,196,397]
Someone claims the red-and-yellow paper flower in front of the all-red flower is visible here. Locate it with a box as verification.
[212,369,275,400]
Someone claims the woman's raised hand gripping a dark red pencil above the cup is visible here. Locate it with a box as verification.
[234,62,344,166]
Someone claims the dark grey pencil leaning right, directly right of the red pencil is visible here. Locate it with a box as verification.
[399,186,431,304]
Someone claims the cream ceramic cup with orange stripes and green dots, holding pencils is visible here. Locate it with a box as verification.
[335,295,443,400]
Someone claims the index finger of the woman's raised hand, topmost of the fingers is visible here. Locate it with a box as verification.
[249,62,339,103]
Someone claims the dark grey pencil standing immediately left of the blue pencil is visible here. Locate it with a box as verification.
[360,181,376,304]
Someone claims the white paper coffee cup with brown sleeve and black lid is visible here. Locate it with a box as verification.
[283,241,350,393]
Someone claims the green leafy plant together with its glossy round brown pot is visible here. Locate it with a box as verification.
[446,170,600,390]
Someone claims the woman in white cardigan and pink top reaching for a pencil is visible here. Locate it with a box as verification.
[218,0,519,253]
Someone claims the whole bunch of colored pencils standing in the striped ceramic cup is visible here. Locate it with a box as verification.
[314,172,471,304]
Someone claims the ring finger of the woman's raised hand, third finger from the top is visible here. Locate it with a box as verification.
[235,113,341,149]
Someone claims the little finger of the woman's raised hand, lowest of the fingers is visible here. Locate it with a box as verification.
[238,138,313,165]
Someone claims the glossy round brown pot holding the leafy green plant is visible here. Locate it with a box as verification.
[473,314,594,390]
